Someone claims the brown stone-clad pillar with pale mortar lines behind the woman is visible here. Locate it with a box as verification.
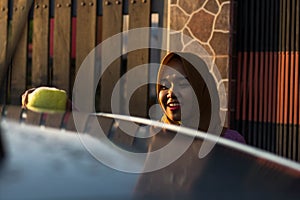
[168,0,231,125]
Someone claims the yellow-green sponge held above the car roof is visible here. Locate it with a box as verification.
[26,87,68,113]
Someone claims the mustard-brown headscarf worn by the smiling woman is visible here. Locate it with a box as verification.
[156,52,221,132]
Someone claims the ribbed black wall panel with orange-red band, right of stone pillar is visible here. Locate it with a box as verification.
[231,0,300,160]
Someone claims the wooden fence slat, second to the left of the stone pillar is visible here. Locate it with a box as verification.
[100,1,123,112]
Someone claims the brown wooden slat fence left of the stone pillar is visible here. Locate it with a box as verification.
[0,0,167,117]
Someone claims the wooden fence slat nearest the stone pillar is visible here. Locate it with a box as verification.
[127,0,151,117]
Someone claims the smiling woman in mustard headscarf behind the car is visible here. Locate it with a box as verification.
[156,52,245,143]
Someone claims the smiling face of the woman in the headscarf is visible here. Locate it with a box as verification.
[158,58,197,122]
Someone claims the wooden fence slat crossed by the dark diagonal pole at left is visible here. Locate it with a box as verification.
[10,0,31,105]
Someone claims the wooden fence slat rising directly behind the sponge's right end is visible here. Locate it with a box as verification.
[52,0,71,95]
